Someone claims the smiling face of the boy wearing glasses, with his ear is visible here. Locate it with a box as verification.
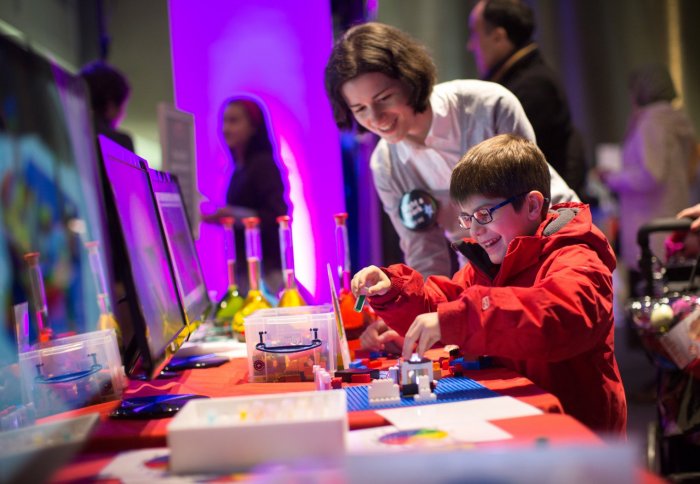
[459,191,544,264]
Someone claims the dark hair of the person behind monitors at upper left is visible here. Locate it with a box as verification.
[80,61,131,116]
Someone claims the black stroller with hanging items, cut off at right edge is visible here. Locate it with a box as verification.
[627,218,700,482]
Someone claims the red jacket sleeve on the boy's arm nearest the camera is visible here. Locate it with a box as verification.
[437,245,614,361]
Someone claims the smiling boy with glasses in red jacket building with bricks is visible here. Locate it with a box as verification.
[352,134,627,436]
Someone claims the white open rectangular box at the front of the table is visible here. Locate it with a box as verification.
[167,391,348,474]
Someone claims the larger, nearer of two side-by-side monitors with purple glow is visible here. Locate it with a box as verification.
[99,135,185,378]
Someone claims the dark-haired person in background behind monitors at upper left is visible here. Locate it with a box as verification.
[80,61,134,152]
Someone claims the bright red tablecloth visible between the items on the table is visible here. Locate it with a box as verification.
[42,355,660,482]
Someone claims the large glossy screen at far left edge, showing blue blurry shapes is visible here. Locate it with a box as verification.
[0,35,113,367]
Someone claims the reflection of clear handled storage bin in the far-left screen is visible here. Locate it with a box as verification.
[19,329,126,417]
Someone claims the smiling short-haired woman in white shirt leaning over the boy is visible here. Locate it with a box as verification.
[325,22,577,277]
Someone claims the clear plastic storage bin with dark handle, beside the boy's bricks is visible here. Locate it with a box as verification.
[244,304,337,383]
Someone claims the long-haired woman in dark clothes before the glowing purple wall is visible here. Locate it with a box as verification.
[202,96,289,295]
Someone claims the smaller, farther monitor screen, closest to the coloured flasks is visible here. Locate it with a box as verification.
[149,170,210,322]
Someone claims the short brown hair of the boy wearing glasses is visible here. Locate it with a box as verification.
[450,134,551,210]
